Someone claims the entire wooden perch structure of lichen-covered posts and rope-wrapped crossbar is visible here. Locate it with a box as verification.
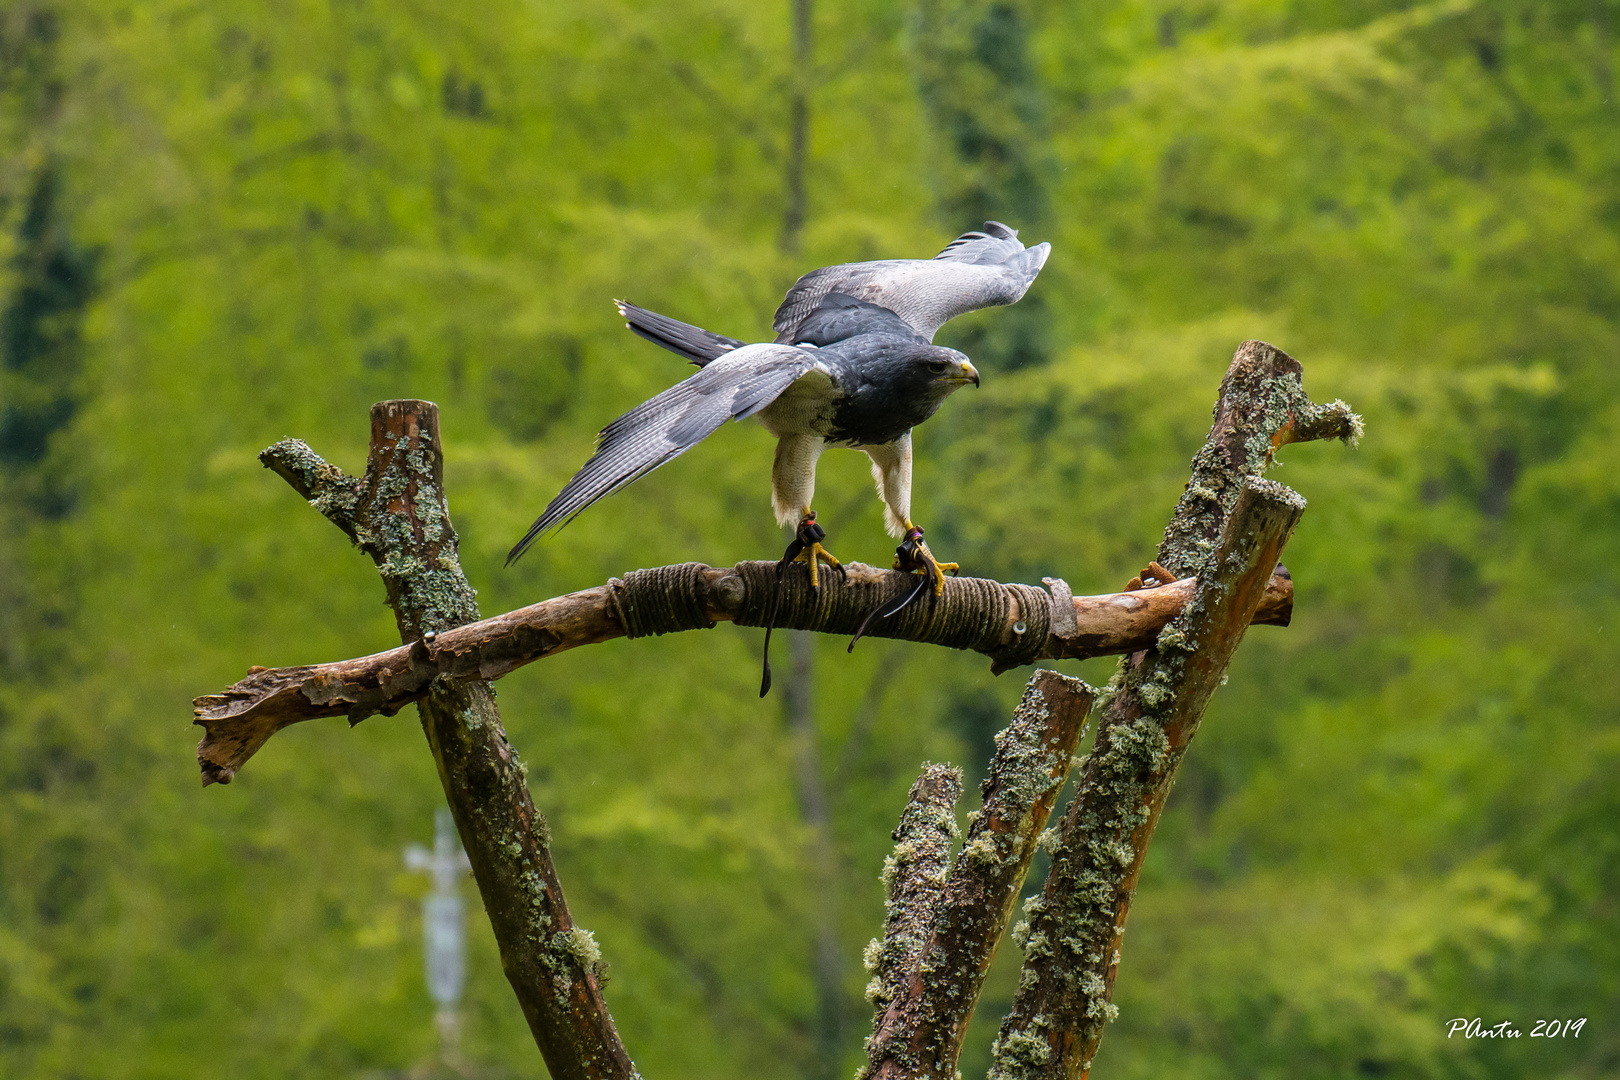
[194,333,1361,1080]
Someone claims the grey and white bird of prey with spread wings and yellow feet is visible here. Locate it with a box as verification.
[507,222,1051,594]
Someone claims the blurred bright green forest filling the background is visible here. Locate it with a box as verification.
[0,0,1620,1080]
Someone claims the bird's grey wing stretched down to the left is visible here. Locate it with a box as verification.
[507,345,816,565]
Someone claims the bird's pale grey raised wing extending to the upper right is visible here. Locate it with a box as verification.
[773,222,1051,343]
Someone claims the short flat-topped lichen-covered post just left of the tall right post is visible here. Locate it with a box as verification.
[863,670,1095,1080]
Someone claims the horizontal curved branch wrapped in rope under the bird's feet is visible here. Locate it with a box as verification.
[193,562,1293,784]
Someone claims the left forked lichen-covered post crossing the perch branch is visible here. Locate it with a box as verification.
[249,402,638,1080]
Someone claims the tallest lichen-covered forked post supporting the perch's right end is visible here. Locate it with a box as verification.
[972,342,1362,1080]
